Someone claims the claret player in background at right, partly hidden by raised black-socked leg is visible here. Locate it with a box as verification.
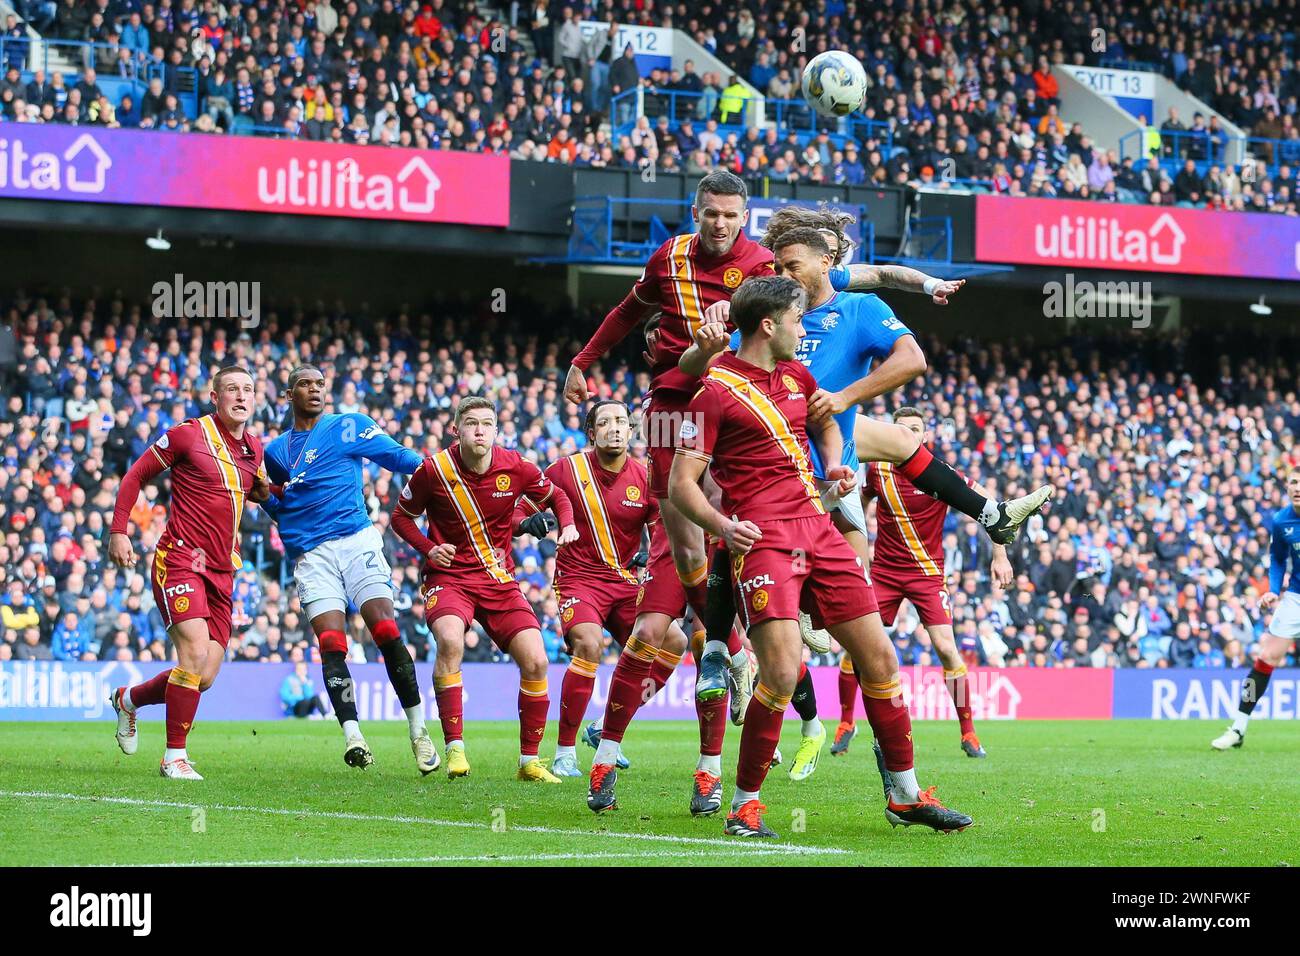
[832,406,1014,757]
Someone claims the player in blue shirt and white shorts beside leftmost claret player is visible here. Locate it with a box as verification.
[265,365,441,774]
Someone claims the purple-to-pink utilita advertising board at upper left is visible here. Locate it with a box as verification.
[0,124,510,226]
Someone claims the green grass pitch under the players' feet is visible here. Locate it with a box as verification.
[0,721,1300,866]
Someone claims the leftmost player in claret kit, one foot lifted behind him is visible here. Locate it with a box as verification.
[108,365,270,780]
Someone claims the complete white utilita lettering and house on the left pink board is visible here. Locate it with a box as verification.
[257,156,442,215]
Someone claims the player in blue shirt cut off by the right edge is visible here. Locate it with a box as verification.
[1210,466,1300,750]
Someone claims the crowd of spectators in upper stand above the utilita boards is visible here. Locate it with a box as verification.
[0,0,1300,215]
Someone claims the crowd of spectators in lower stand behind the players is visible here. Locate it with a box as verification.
[0,291,1300,667]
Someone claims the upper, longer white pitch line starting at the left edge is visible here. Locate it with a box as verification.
[0,790,849,856]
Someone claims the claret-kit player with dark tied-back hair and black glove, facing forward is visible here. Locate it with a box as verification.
[509,399,686,777]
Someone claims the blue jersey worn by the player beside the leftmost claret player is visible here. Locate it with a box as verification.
[265,412,424,559]
